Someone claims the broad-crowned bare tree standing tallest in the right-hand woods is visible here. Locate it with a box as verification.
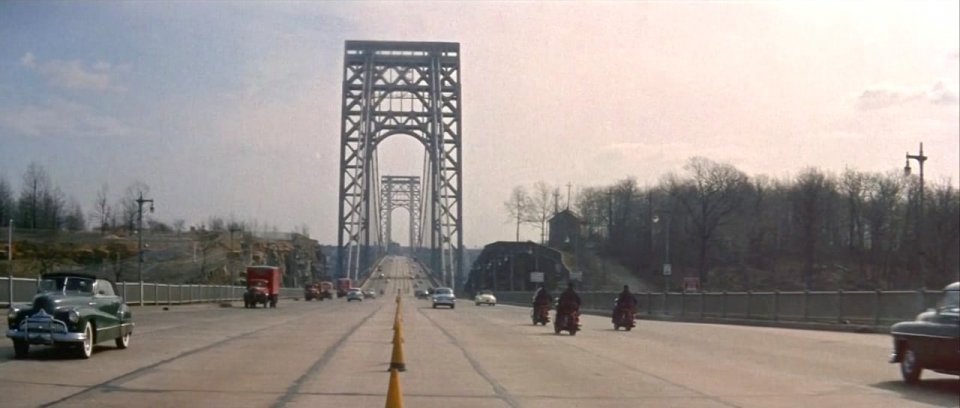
[666,157,748,284]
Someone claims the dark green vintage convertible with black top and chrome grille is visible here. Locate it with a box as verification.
[7,273,133,358]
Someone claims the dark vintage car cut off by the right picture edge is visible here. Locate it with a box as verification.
[890,282,960,384]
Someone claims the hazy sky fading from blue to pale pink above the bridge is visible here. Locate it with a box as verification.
[0,1,960,247]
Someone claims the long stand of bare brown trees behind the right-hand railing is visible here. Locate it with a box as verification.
[504,157,960,290]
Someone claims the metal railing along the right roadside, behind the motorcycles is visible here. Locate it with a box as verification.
[496,290,943,326]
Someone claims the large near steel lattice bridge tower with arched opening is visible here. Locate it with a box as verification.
[337,41,464,286]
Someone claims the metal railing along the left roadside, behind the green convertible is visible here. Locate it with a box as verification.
[0,278,303,307]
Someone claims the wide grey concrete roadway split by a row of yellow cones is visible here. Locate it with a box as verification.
[0,258,960,408]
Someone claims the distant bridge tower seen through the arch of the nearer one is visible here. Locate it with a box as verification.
[380,176,423,253]
